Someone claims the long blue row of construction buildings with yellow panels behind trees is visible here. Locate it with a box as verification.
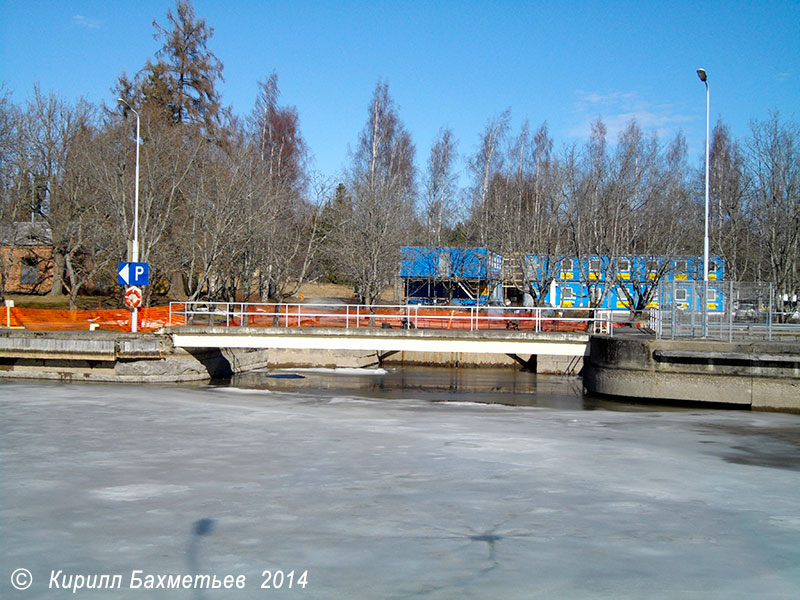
[401,247,725,312]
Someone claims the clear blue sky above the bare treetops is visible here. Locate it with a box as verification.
[0,0,800,181]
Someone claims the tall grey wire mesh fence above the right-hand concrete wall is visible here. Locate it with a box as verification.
[651,281,800,341]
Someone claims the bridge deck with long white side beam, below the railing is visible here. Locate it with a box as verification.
[167,327,589,356]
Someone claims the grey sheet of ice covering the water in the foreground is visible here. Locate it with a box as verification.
[0,374,800,599]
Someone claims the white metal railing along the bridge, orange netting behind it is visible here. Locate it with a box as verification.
[169,302,615,334]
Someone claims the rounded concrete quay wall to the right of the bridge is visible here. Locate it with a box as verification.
[584,336,800,412]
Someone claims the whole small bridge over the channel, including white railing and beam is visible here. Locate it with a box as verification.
[167,302,596,373]
